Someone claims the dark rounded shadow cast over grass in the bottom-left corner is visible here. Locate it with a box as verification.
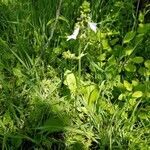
[0,95,69,150]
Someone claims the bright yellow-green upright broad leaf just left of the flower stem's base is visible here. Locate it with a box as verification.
[64,70,77,94]
